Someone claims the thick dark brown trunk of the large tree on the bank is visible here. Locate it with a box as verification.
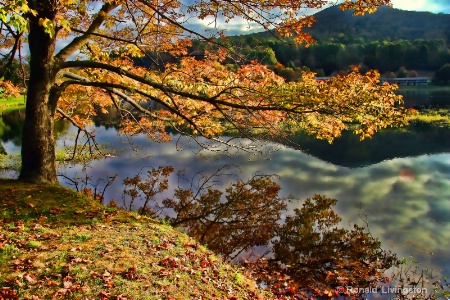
[19,1,58,183]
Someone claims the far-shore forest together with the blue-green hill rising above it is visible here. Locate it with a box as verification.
[202,6,450,83]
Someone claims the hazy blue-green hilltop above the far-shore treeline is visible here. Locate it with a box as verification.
[307,6,450,41]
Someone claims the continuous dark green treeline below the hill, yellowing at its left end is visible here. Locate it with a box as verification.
[217,35,450,75]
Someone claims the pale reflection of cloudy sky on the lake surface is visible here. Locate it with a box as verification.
[45,123,450,282]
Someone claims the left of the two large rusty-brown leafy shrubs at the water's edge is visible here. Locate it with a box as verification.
[163,176,286,258]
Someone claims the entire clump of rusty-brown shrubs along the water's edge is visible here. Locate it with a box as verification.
[120,167,399,297]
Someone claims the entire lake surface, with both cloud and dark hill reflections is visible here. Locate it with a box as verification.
[0,89,450,290]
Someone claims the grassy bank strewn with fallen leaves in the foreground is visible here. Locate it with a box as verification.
[0,179,262,299]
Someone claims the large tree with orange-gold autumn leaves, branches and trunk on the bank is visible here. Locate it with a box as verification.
[0,0,405,182]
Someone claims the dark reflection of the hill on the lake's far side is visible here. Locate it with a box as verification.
[286,123,450,168]
